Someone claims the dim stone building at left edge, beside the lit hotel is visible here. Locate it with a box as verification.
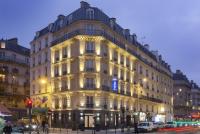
[0,38,30,117]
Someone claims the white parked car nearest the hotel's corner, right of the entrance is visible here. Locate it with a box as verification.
[138,122,156,132]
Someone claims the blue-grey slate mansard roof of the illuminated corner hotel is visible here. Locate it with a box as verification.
[34,1,171,72]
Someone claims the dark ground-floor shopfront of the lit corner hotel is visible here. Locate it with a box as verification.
[50,108,173,130]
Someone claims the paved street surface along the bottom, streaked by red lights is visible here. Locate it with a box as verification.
[19,128,200,134]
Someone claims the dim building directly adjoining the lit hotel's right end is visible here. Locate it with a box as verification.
[173,70,192,118]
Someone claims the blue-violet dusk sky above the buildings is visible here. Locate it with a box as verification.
[0,0,200,84]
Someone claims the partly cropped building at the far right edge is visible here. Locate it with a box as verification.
[191,81,200,112]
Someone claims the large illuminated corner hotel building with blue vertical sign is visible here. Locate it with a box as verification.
[30,1,173,128]
